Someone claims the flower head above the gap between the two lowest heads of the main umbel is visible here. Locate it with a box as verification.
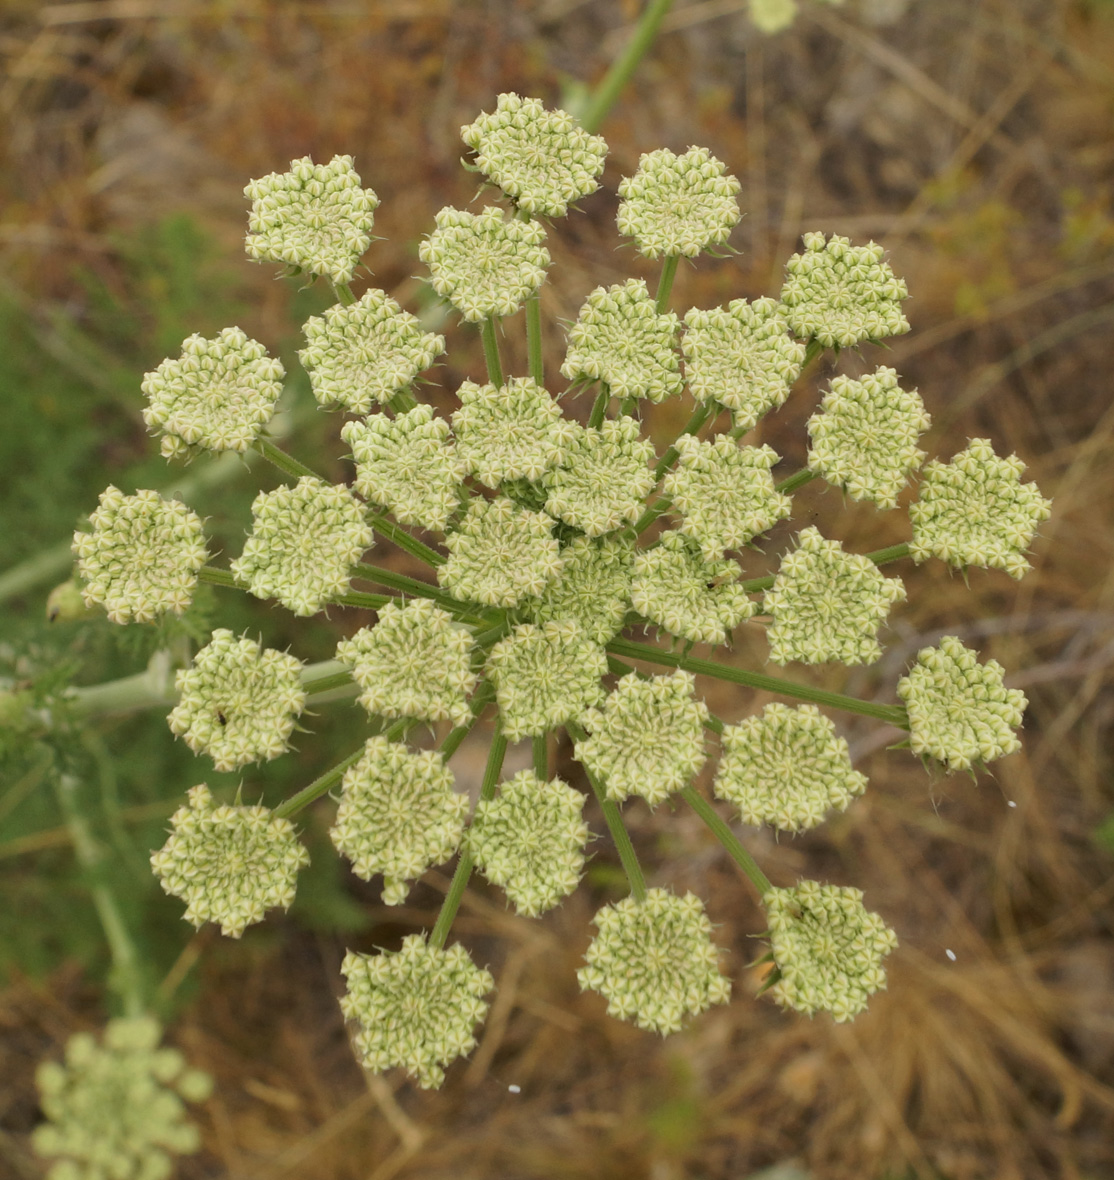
[467,771,588,918]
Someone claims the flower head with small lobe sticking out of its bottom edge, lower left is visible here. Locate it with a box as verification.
[329,736,468,905]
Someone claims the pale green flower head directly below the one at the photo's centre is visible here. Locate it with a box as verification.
[485,620,608,741]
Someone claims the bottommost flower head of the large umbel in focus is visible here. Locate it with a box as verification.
[340,935,496,1089]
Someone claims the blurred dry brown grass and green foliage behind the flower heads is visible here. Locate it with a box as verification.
[0,0,1114,1180]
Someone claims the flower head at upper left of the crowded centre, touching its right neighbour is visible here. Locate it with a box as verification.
[340,406,467,532]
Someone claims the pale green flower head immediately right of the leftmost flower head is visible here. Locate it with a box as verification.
[231,476,372,615]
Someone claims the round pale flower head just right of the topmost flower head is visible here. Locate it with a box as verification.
[617,148,740,258]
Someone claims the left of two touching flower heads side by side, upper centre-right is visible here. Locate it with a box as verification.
[561,278,684,402]
